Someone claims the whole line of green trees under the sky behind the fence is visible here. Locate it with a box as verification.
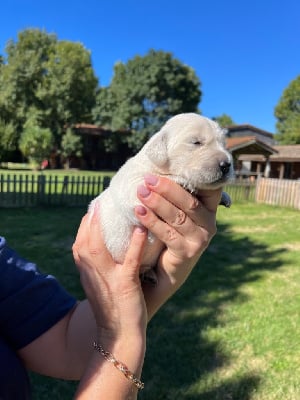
[0,29,300,169]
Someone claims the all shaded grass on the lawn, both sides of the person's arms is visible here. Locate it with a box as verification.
[0,208,286,400]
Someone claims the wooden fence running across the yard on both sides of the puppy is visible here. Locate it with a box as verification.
[0,174,300,210]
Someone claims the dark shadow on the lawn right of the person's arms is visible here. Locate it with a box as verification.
[139,224,283,400]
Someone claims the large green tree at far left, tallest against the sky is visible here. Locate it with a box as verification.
[0,29,98,158]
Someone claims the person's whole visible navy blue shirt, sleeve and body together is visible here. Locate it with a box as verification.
[0,236,76,400]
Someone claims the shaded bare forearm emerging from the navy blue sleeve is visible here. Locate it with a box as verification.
[19,300,97,380]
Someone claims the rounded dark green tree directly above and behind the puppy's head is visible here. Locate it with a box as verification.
[93,50,201,149]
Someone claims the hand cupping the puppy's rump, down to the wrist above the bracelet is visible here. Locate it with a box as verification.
[73,209,147,346]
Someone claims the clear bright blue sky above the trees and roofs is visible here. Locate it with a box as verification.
[0,0,300,133]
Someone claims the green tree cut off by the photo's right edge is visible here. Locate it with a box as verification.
[275,75,300,144]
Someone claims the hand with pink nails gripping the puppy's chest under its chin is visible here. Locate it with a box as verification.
[135,175,221,318]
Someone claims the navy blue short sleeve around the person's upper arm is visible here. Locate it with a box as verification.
[0,237,76,350]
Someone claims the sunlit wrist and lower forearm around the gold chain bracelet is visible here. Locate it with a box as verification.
[75,335,146,400]
